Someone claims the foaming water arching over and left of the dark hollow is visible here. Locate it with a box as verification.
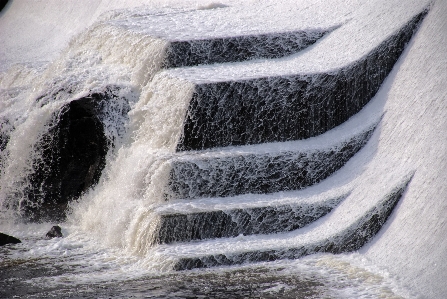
[0,8,172,221]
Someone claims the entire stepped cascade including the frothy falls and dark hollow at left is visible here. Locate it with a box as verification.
[0,0,446,298]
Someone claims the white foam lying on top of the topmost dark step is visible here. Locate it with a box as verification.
[109,0,346,41]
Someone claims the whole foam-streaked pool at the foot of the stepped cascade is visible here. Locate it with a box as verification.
[0,224,411,298]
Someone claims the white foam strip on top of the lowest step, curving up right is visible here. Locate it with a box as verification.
[151,169,408,260]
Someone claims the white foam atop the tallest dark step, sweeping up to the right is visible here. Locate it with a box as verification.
[166,0,429,84]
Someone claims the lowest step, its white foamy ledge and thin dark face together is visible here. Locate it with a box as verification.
[172,178,411,270]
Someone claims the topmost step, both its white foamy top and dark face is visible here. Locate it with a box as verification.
[105,4,340,68]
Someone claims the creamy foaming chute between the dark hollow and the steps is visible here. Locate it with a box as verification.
[70,77,197,255]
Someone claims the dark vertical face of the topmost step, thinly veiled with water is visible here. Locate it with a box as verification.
[163,28,333,68]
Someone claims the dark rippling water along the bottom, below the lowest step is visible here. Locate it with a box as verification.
[0,252,325,298]
